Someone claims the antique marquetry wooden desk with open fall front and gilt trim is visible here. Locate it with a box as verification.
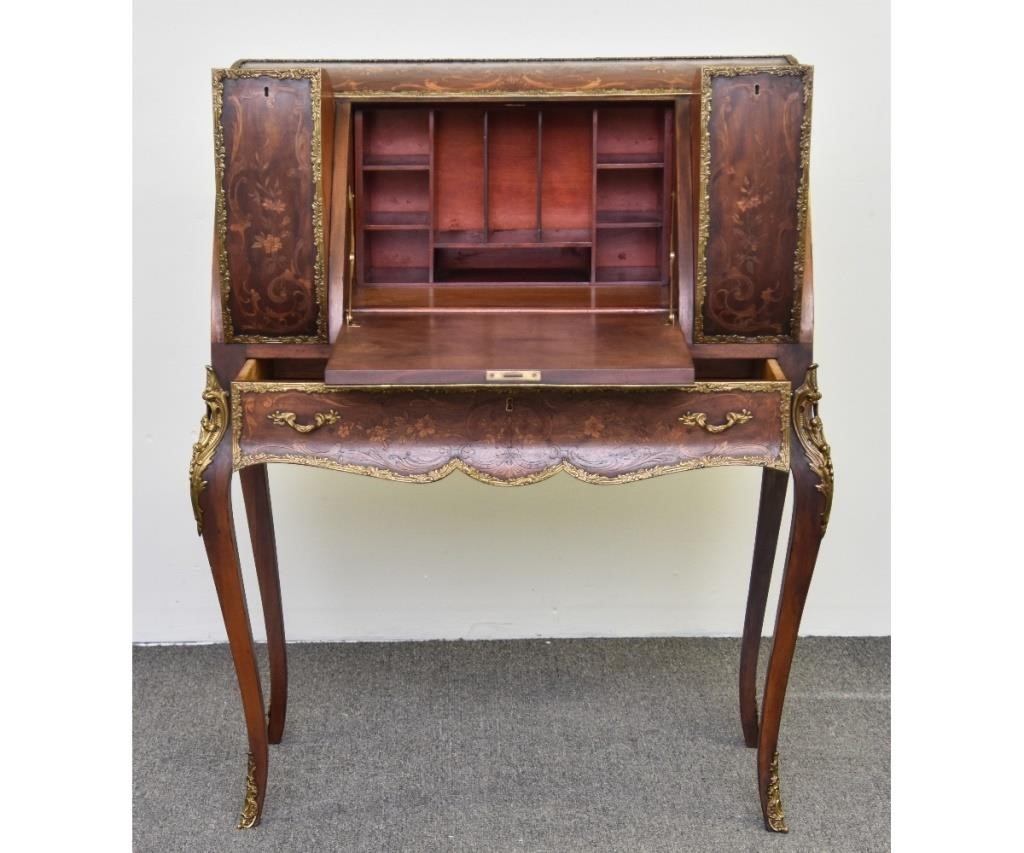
[189,56,833,831]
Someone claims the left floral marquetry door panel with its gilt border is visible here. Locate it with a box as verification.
[214,70,326,342]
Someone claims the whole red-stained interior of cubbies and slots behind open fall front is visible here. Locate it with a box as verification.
[354,101,673,301]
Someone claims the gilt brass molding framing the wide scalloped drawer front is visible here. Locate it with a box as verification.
[230,381,793,485]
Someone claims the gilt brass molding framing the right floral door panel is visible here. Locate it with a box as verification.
[693,65,814,343]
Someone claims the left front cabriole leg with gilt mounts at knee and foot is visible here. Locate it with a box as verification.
[189,368,267,828]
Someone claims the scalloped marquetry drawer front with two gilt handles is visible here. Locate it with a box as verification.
[231,382,791,485]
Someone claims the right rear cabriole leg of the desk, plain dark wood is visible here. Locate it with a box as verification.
[739,468,790,747]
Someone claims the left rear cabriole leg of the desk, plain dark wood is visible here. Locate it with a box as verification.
[239,465,288,743]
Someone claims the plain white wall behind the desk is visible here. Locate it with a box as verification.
[133,0,889,642]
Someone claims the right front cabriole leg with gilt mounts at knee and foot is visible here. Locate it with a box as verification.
[758,365,835,833]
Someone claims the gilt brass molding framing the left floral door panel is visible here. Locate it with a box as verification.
[213,68,328,343]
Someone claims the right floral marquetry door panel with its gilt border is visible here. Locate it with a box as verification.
[695,66,811,341]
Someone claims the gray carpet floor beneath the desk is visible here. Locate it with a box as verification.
[133,637,890,853]
